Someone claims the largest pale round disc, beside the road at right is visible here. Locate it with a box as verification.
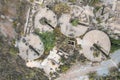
[81,30,111,61]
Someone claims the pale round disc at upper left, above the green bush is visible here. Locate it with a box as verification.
[34,7,57,32]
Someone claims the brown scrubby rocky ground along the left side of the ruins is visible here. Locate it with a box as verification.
[0,0,48,80]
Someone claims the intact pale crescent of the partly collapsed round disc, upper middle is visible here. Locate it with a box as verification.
[59,14,88,37]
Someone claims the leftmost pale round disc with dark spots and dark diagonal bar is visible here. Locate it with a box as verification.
[18,33,44,61]
